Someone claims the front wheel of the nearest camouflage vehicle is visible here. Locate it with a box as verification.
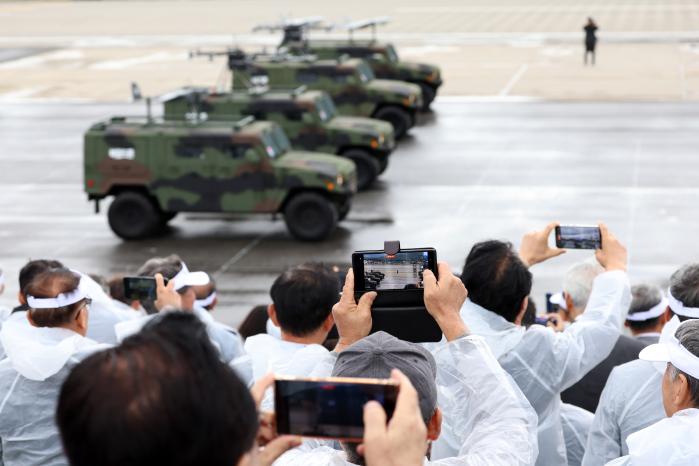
[284,192,338,241]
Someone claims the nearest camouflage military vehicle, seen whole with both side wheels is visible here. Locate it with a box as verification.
[84,117,356,241]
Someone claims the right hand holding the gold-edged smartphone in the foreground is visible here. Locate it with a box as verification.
[357,369,427,466]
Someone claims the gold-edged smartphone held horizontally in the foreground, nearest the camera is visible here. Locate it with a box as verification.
[274,377,398,442]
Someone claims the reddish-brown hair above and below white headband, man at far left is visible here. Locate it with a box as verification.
[22,268,85,327]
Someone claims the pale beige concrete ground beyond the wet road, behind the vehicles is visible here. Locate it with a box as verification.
[0,0,699,102]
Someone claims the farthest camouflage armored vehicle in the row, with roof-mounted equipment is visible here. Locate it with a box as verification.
[255,17,442,110]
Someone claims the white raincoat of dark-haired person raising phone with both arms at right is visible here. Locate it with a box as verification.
[461,271,631,466]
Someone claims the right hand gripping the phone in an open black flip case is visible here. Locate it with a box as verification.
[422,261,469,341]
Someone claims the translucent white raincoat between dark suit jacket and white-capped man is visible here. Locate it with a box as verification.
[583,359,665,466]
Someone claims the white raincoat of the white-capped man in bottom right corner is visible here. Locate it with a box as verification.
[607,408,699,466]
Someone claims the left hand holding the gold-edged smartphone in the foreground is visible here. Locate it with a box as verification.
[250,374,301,466]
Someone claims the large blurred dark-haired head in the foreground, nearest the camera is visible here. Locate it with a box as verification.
[56,312,258,466]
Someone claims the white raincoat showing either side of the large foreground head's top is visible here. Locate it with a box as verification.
[115,307,253,386]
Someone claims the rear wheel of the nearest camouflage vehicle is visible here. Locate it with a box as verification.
[107,191,161,240]
